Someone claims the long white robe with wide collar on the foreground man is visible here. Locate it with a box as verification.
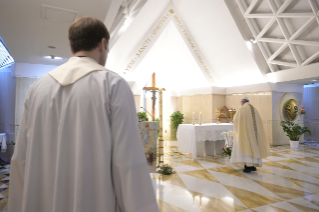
[9,57,158,212]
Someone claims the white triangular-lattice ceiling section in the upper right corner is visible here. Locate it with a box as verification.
[236,0,319,72]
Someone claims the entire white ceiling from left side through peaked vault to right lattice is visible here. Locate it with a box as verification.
[0,0,319,88]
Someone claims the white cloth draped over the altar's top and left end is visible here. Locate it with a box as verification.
[177,123,234,159]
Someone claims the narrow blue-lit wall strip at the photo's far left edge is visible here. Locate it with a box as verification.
[0,72,16,141]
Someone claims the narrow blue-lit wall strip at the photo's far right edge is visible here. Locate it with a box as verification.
[303,87,319,141]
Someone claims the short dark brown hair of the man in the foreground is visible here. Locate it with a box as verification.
[69,17,110,53]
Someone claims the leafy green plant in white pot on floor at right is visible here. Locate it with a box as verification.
[280,121,311,149]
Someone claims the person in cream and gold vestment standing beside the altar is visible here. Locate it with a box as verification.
[230,97,270,172]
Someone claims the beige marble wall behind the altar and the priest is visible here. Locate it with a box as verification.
[172,91,304,145]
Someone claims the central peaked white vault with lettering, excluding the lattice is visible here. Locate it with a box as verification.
[107,0,266,88]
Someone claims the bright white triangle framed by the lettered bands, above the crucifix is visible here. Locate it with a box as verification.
[129,21,210,92]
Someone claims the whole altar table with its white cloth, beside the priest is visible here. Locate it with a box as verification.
[177,123,234,159]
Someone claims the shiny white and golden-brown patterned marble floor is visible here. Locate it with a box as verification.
[152,142,319,212]
